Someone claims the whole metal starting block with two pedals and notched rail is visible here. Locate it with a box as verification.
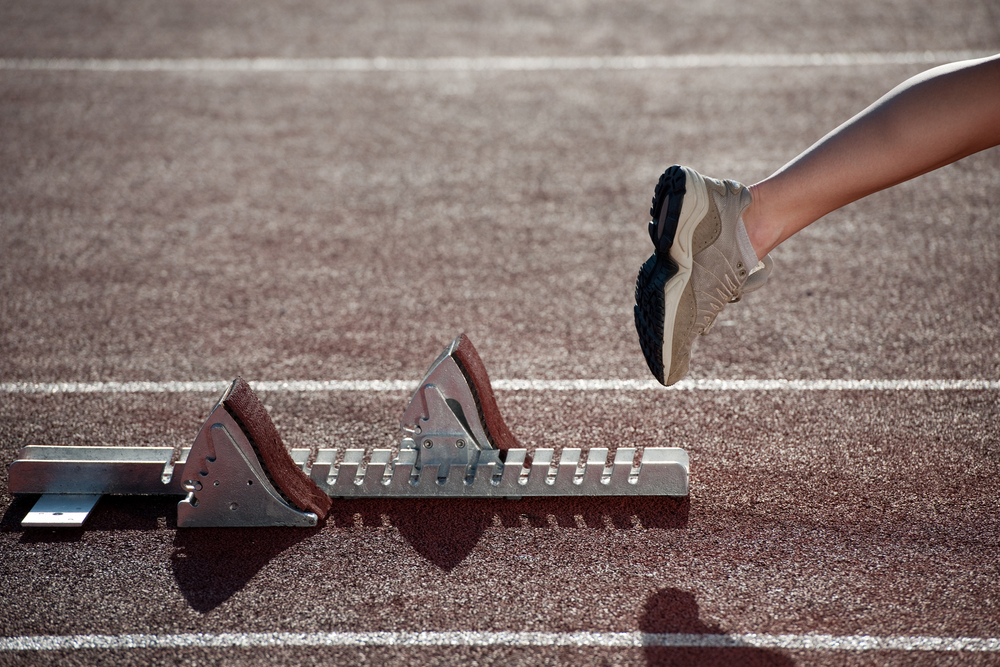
[9,334,688,528]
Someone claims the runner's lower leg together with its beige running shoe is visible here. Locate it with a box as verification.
[635,56,1000,385]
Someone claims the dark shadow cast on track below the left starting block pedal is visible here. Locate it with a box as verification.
[170,526,322,613]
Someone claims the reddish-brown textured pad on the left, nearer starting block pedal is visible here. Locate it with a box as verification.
[223,378,331,519]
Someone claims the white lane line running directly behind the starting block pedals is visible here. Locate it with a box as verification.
[0,380,1000,394]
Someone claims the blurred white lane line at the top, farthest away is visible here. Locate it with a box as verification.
[0,50,992,72]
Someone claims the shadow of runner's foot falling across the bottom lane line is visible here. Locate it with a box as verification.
[639,588,795,667]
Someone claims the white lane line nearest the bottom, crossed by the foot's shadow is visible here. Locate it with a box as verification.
[0,632,1000,653]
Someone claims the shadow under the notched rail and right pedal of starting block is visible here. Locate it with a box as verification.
[326,496,690,572]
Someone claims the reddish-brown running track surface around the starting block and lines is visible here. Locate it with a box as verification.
[0,0,1000,666]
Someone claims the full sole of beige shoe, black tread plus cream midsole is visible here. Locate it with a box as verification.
[634,165,709,385]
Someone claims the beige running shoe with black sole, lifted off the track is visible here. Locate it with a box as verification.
[635,165,773,386]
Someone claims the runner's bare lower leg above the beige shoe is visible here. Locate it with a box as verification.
[743,55,1000,257]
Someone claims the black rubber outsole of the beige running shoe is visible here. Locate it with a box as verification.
[634,165,686,385]
